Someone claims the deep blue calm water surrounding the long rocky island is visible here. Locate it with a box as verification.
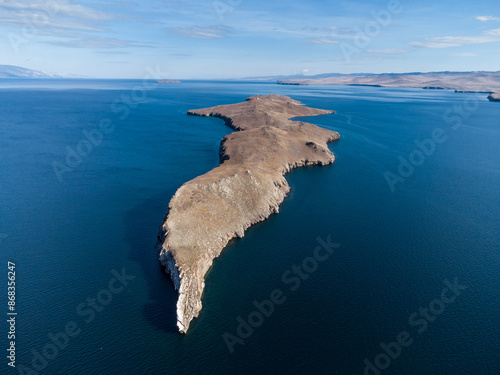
[0,80,500,375]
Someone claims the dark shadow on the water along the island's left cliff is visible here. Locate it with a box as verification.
[125,188,179,334]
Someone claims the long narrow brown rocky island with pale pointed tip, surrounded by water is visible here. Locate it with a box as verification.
[158,95,340,333]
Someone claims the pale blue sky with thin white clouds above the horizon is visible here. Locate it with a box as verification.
[0,0,500,79]
